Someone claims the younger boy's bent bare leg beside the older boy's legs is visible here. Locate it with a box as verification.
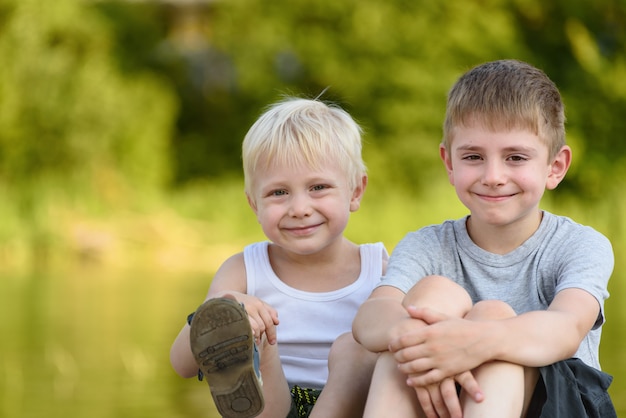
[309,333,378,418]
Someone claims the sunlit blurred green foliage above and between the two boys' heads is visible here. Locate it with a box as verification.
[212,0,523,186]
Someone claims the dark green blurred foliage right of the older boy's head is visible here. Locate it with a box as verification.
[514,0,626,199]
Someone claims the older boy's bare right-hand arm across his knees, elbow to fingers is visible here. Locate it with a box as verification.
[391,289,600,386]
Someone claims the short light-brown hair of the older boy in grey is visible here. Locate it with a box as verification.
[443,60,565,158]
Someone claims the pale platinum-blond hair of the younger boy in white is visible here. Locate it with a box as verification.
[242,97,366,194]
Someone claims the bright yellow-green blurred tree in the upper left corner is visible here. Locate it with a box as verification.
[0,0,174,204]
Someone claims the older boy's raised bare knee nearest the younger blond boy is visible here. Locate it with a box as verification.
[402,275,472,317]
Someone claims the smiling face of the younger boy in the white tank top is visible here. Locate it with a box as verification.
[243,159,360,255]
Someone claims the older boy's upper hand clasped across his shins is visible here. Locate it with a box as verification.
[389,307,487,386]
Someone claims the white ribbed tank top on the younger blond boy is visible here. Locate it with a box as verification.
[243,241,389,389]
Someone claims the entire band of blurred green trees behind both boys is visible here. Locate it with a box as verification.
[0,0,626,262]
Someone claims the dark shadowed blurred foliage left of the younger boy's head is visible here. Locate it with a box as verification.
[96,1,260,183]
